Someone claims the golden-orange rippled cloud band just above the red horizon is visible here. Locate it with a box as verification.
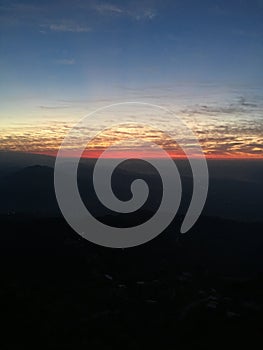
[0,122,263,158]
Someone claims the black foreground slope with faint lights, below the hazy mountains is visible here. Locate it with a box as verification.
[0,215,263,349]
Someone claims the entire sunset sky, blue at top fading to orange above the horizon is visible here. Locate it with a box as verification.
[0,0,263,158]
